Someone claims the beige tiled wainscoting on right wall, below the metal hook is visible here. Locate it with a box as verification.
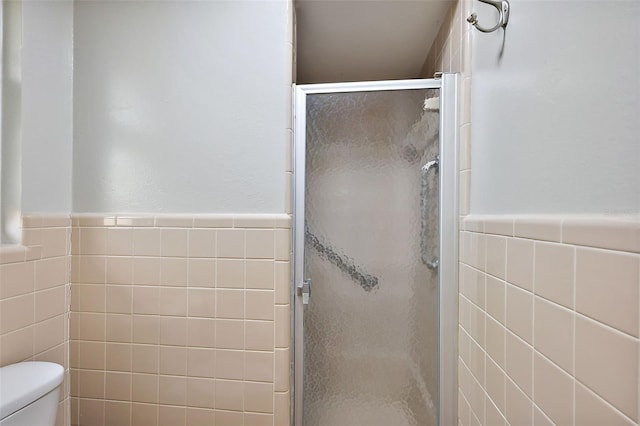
[459,216,640,426]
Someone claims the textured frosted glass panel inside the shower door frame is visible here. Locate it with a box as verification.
[303,89,439,426]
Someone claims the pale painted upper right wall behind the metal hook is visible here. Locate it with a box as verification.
[471,0,640,214]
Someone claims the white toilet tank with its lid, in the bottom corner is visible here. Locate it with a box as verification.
[0,361,64,426]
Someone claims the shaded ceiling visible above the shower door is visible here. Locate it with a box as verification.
[295,0,451,83]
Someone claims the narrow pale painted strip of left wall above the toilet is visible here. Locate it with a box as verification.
[21,1,73,213]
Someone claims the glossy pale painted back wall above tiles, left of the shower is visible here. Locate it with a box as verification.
[73,0,292,213]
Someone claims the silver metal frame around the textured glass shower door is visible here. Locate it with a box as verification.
[290,74,459,426]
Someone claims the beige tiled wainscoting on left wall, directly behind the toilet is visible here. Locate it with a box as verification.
[0,215,71,426]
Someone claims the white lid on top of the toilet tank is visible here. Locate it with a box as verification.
[0,361,64,419]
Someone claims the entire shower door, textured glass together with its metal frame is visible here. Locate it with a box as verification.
[292,74,457,426]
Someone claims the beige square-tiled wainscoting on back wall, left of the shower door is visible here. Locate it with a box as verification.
[70,215,291,426]
